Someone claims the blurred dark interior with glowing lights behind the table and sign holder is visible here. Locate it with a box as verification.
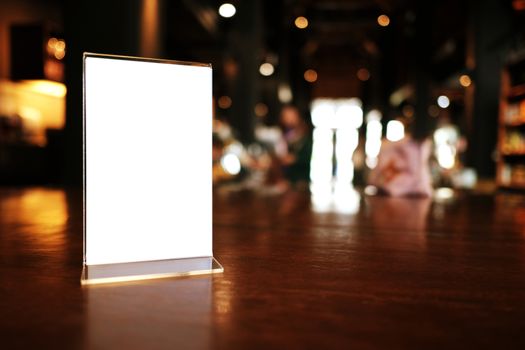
[0,0,525,196]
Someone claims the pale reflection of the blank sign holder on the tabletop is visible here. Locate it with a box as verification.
[84,276,212,349]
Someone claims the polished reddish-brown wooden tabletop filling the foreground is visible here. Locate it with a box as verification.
[0,188,525,349]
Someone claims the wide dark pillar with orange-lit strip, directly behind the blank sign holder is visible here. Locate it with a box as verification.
[64,0,164,185]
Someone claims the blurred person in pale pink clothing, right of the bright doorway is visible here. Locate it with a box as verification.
[369,137,432,197]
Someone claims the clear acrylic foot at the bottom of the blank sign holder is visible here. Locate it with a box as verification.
[80,256,224,285]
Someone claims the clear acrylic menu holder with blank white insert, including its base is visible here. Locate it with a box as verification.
[81,53,223,285]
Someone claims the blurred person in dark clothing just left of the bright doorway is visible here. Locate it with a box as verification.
[279,105,313,185]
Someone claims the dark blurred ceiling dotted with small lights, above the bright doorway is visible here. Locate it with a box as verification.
[166,0,468,95]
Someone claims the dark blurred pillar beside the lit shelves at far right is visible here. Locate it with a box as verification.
[467,0,511,178]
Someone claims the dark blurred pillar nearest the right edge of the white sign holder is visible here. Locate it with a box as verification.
[230,0,263,143]
